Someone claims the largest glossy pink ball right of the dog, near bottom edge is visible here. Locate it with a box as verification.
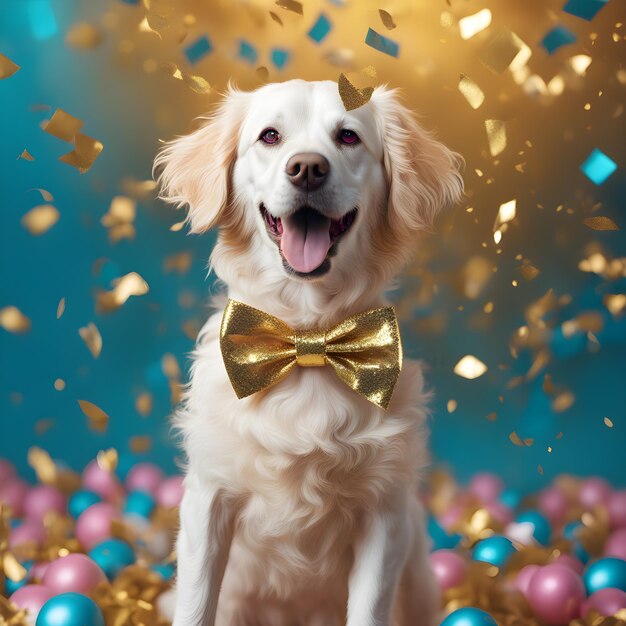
[527,563,585,626]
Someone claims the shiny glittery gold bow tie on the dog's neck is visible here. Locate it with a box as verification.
[220,300,402,409]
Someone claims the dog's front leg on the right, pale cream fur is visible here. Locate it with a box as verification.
[347,503,410,626]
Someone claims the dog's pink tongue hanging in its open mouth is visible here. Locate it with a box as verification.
[280,210,330,273]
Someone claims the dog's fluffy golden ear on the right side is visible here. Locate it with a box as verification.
[372,87,463,234]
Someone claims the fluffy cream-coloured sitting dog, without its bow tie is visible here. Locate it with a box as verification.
[155,80,463,626]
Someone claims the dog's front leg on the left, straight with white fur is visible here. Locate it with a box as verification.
[173,474,233,626]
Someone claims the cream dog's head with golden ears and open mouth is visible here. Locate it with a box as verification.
[155,80,463,288]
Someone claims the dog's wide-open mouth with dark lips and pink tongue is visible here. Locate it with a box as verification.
[260,204,357,275]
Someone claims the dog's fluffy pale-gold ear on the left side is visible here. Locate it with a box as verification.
[153,86,248,233]
